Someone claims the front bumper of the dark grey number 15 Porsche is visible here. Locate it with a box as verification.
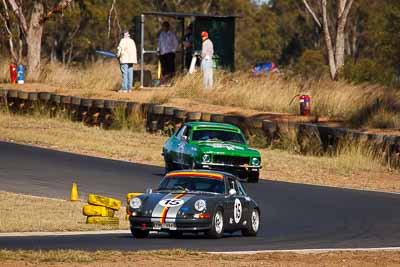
[129,216,211,232]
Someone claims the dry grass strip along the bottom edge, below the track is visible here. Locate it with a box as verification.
[0,250,400,267]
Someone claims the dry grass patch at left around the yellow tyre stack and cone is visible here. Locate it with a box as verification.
[0,191,129,233]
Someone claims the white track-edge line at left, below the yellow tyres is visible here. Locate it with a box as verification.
[0,230,131,237]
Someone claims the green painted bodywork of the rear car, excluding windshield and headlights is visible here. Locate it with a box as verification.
[163,122,261,177]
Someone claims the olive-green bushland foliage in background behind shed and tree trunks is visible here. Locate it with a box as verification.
[0,0,400,86]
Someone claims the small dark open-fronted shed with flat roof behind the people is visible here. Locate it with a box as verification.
[134,12,238,87]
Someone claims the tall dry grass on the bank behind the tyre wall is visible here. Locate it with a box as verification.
[0,60,400,127]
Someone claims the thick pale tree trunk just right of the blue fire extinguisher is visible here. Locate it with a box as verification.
[26,1,44,81]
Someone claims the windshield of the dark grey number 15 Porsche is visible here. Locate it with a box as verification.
[158,176,225,194]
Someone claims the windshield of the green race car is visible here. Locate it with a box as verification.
[192,130,245,144]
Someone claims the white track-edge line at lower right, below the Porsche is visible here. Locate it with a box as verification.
[208,247,400,254]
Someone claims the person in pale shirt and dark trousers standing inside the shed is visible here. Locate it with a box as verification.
[157,21,179,80]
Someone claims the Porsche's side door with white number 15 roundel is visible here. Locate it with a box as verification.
[224,176,246,230]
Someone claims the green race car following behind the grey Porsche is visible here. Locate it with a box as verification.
[162,122,261,182]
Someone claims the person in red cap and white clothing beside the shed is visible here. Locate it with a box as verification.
[201,31,214,89]
